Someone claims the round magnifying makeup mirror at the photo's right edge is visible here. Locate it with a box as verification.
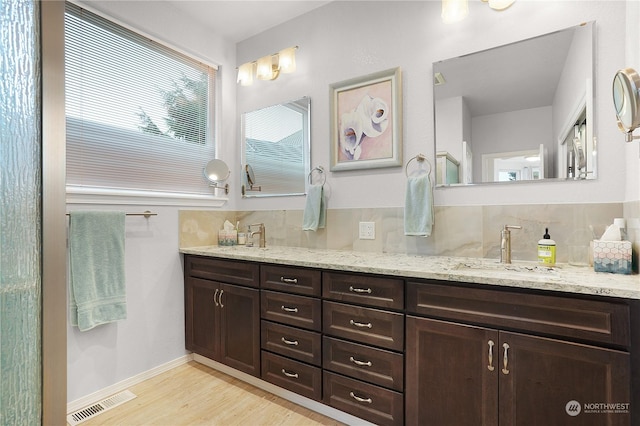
[613,68,640,142]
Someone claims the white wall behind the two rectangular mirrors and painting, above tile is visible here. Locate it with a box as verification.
[236,0,639,210]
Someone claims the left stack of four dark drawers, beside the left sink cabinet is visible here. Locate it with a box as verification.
[260,265,322,401]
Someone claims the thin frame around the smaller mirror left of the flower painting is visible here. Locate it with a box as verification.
[240,96,311,198]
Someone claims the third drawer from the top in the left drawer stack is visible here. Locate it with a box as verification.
[262,320,322,366]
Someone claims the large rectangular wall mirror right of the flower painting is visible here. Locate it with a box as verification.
[433,22,597,186]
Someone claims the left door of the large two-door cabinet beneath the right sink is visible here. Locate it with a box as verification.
[405,315,500,426]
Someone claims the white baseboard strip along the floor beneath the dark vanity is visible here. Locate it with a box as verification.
[193,354,375,426]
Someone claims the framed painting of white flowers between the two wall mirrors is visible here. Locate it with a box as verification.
[329,67,402,171]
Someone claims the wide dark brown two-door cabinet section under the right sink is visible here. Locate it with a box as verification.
[405,282,631,426]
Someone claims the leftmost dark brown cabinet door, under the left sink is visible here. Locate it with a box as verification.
[185,277,220,359]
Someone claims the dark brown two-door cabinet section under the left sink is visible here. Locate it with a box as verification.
[184,256,260,377]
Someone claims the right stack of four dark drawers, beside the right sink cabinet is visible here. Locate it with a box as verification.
[322,271,404,425]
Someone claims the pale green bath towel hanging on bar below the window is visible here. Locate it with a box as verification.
[69,211,127,331]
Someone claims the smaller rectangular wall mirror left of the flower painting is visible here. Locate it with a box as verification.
[240,97,311,197]
